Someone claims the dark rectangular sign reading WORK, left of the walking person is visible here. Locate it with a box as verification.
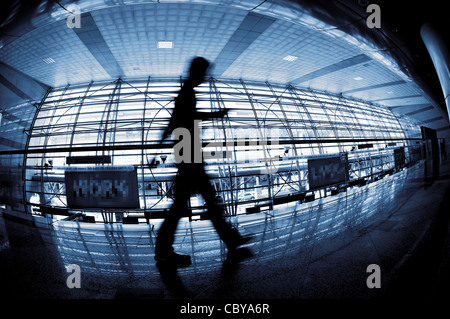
[65,166,139,208]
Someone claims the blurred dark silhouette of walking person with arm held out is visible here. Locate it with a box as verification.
[155,57,252,268]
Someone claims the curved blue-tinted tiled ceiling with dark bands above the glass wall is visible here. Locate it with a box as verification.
[0,0,450,132]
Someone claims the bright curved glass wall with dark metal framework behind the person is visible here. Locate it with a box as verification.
[24,78,420,220]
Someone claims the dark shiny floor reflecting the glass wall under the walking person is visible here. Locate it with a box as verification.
[0,162,450,300]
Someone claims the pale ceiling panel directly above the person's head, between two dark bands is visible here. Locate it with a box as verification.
[91,4,247,78]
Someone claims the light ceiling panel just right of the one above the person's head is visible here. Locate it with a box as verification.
[223,20,361,84]
